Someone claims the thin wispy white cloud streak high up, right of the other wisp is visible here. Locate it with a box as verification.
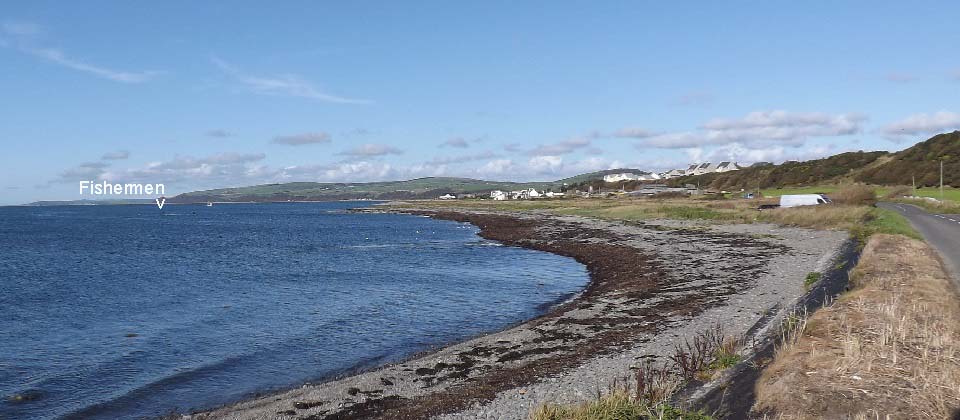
[211,57,372,104]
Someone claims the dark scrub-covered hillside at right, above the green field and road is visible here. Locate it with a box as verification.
[668,131,960,190]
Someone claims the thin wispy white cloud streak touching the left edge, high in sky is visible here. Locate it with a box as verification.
[0,22,161,83]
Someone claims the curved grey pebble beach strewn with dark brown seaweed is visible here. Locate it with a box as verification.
[192,208,844,419]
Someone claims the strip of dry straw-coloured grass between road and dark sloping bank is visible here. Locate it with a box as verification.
[755,235,960,419]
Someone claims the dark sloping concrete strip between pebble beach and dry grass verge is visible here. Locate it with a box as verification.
[673,239,861,419]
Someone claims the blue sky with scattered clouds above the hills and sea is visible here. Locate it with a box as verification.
[0,1,960,204]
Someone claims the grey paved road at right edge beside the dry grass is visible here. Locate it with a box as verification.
[877,203,960,287]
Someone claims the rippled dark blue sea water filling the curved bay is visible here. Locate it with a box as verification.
[0,203,587,419]
